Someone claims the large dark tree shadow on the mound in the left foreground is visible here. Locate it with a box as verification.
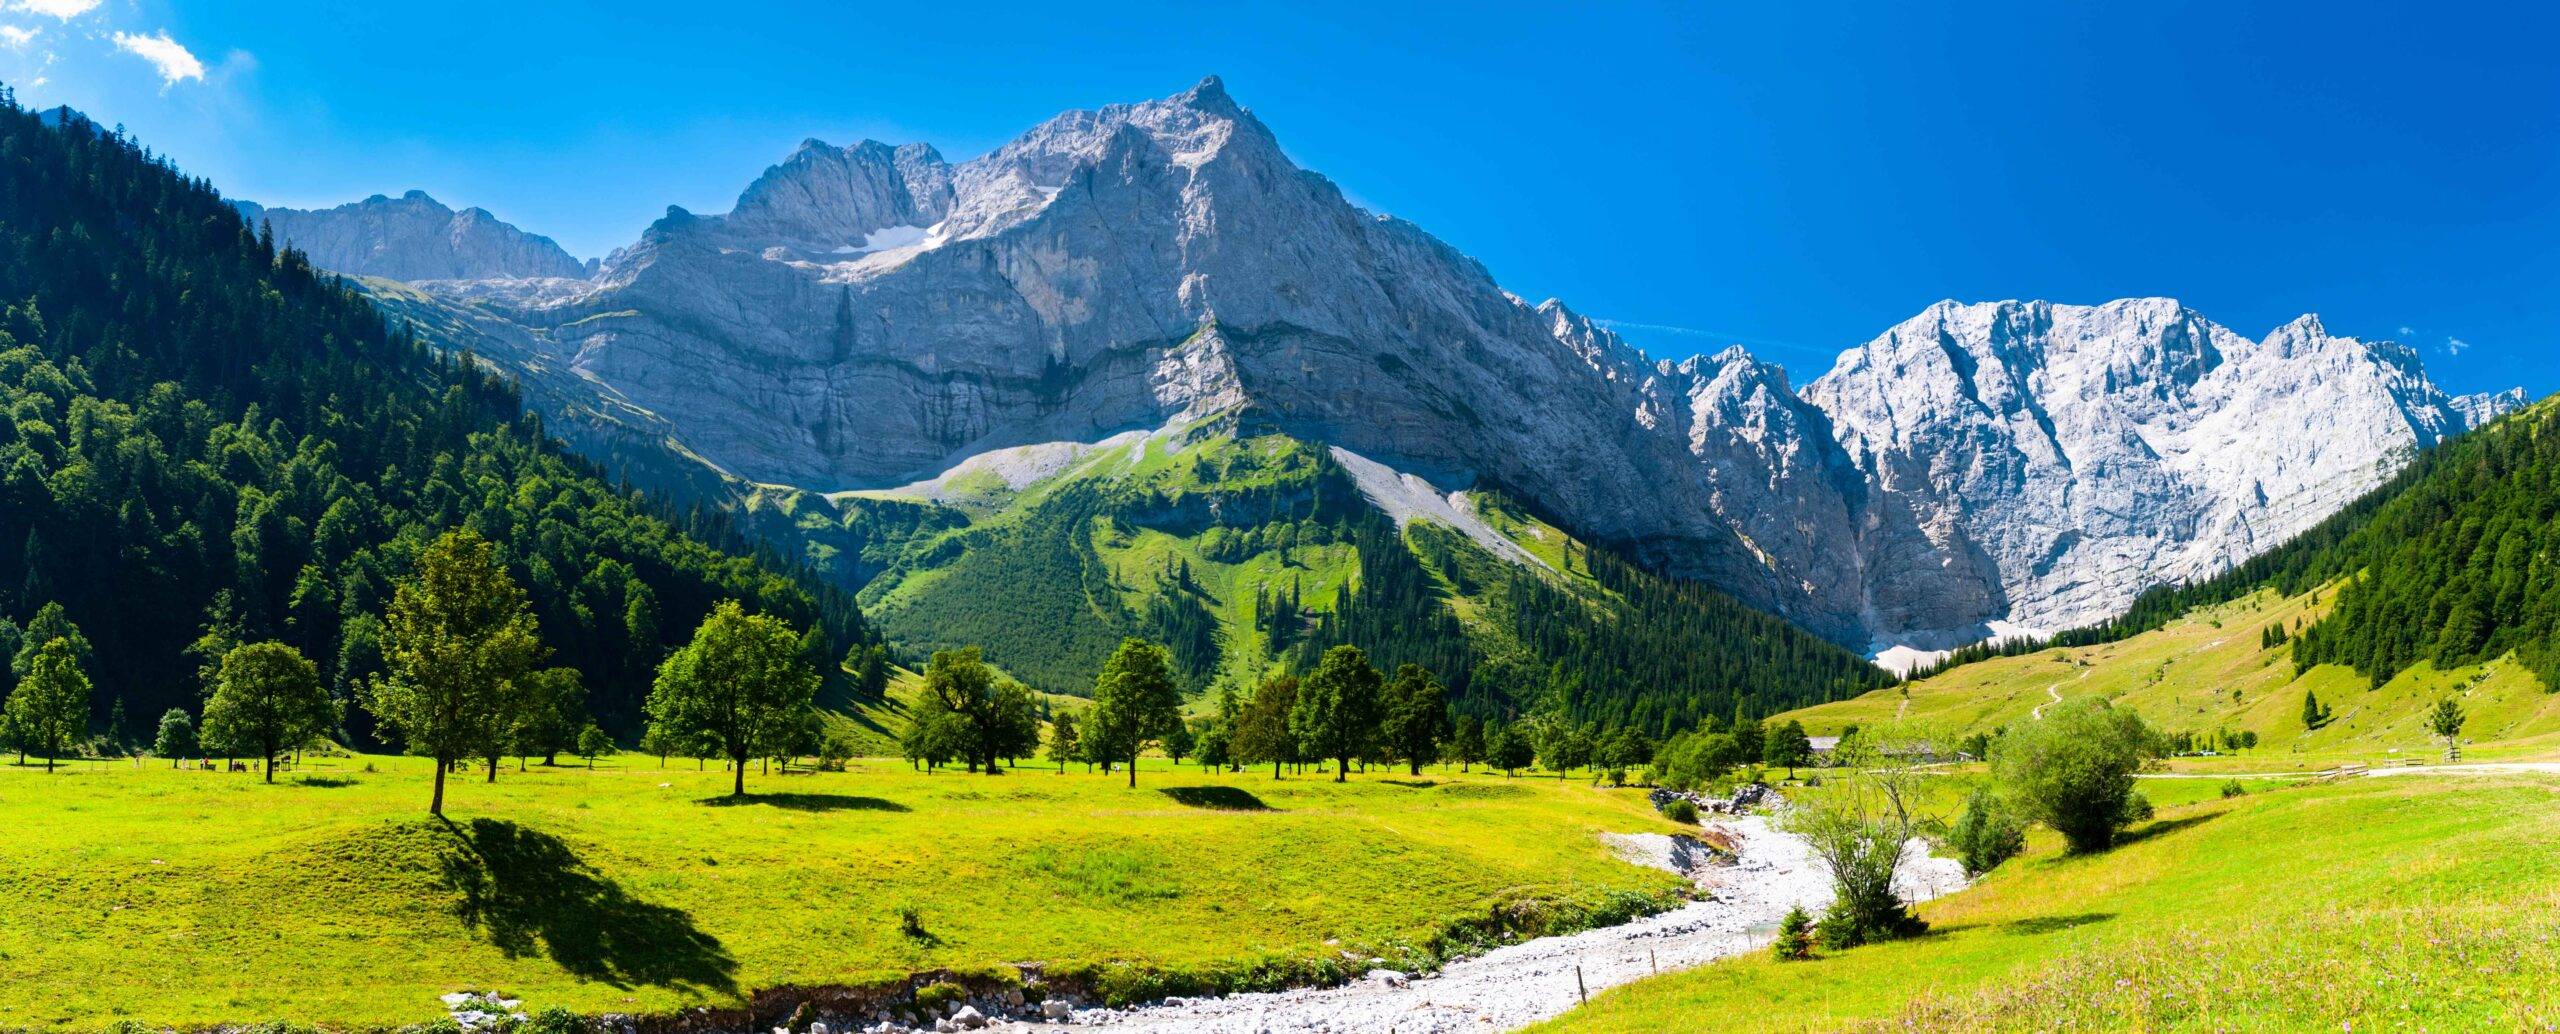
[440,819,737,993]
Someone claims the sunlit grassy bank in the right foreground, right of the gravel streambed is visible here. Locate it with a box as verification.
[1536,778,2560,1034]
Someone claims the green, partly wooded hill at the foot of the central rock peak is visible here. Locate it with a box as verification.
[773,420,1884,732]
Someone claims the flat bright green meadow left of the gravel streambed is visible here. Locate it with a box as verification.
[0,758,1677,1029]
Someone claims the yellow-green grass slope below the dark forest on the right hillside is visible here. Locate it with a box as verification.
[1787,589,2560,770]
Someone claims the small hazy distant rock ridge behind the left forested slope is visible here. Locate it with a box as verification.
[233,189,591,282]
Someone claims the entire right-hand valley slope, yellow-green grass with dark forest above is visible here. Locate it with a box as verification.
[1792,399,2560,763]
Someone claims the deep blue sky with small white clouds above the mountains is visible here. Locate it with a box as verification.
[0,0,2560,394]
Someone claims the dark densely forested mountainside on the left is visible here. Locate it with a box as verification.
[0,100,870,740]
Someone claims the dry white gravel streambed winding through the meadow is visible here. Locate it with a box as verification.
[1049,816,1964,1034]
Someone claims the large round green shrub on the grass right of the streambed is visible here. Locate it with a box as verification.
[1992,696,2156,855]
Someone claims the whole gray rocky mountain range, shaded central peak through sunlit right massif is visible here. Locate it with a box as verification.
[373,79,2514,650]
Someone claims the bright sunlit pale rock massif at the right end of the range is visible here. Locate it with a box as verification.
[1805,299,2519,648]
